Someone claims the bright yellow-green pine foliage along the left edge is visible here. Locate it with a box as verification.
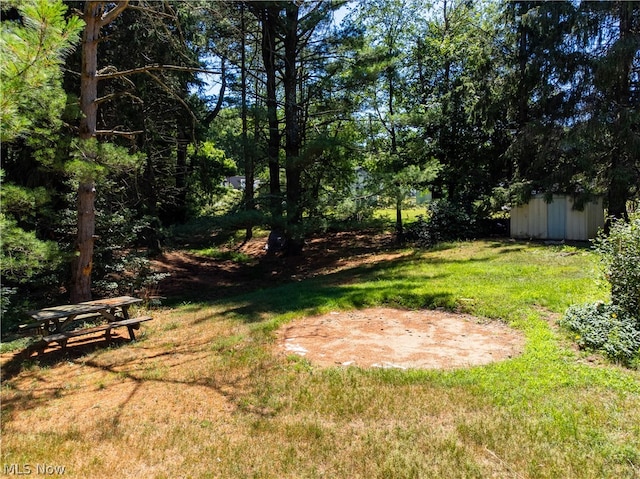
[0,0,82,322]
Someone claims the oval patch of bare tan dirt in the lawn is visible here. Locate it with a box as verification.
[278,308,524,369]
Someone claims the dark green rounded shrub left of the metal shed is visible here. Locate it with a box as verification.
[406,200,476,248]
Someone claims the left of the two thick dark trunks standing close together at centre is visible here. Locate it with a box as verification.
[261,6,282,223]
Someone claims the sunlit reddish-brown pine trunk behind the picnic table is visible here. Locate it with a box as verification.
[70,0,129,303]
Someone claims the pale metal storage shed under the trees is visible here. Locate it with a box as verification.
[511,194,604,241]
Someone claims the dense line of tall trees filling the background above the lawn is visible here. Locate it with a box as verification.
[0,0,640,322]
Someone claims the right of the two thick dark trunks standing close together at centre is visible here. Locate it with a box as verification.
[284,3,303,255]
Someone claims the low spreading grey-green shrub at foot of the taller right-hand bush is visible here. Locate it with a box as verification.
[560,302,640,365]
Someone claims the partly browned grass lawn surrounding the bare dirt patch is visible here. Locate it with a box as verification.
[1,241,640,479]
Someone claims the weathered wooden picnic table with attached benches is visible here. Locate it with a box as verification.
[20,296,152,349]
